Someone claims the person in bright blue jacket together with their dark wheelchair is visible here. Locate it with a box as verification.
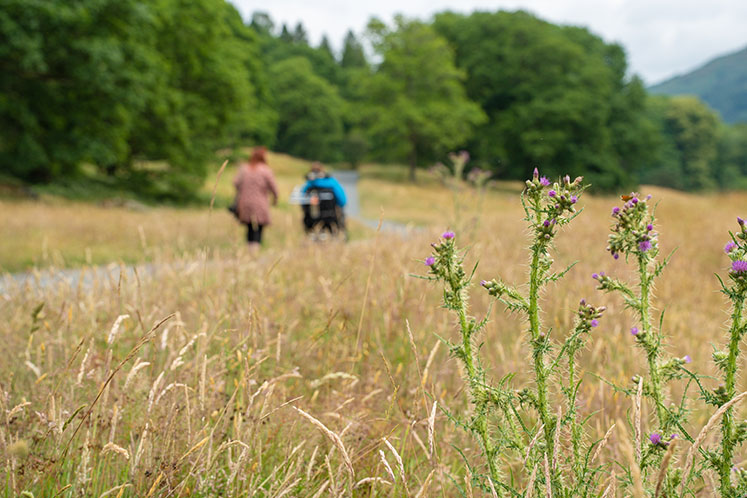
[301,161,347,237]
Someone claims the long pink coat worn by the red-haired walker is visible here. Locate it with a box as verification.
[233,163,278,225]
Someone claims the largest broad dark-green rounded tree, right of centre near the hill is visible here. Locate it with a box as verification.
[434,11,646,189]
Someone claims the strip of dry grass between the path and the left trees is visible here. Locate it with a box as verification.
[0,154,367,273]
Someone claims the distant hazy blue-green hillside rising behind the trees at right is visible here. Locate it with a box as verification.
[649,47,747,123]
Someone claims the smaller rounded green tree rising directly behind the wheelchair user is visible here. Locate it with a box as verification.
[270,57,343,161]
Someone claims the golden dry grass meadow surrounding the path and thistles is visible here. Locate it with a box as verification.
[0,156,747,497]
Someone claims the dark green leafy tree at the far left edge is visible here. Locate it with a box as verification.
[0,0,156,182]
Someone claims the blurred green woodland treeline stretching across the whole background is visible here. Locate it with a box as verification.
[0,0,747,200]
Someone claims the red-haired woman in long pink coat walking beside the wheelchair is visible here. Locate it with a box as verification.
[233,147,278,250]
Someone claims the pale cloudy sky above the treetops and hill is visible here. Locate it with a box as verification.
[230,0,747,84]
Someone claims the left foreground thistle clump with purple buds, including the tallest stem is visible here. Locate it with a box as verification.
[424,170,604,497]
